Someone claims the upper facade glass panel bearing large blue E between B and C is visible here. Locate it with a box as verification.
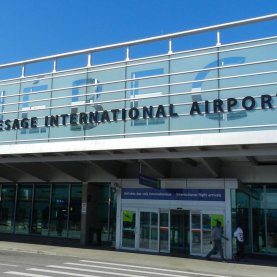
[126,59,169,133]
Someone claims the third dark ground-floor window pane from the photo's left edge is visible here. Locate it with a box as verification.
[31,184,50,236]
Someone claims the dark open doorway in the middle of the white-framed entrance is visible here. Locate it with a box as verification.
[170,210,190,254]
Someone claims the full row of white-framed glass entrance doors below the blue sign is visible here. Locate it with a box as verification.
[121,208,224,256]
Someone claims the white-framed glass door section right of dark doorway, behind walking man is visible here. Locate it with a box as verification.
[190,212,224,256]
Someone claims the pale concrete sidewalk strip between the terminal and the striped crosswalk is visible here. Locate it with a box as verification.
[0,241,277,277]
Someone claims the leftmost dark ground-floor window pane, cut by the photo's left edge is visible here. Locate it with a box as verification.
[0,185,16,233]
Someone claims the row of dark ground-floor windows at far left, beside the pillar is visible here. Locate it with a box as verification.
[0,184,82,239]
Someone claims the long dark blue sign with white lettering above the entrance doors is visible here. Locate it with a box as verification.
[121,188,225,201]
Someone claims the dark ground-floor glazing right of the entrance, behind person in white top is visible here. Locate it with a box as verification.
[232,185,277,255]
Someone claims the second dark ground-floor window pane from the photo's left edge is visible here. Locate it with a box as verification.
[14,184,33,234]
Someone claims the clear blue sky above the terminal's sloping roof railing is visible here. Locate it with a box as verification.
[0,0,277,64]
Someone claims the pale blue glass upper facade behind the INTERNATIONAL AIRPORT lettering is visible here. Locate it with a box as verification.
[0,38,277,144]
